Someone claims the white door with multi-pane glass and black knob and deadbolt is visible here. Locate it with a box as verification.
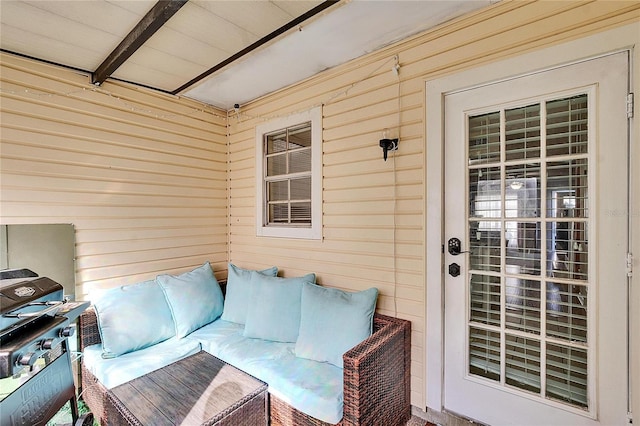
[444,53,629,426]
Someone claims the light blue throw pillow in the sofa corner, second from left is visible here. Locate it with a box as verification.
[156,262,224,338]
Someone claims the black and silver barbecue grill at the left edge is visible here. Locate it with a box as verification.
[0,270,93,426]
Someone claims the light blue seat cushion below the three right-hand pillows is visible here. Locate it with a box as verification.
[188,319,344,424]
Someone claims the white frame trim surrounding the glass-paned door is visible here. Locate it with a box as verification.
[424,22,640,417]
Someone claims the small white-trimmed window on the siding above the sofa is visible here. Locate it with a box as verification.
[256,107,322,239]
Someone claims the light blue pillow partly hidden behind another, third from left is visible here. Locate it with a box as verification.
[222,263,278,324]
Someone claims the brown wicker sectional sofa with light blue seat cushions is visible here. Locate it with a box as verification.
[79,265,411,425]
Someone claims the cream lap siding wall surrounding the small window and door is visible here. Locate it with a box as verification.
[229,2,640,407]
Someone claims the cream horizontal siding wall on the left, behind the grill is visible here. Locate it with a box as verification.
[0,54,227,299]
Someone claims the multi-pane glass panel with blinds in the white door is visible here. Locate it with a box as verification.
[467,94,590,407]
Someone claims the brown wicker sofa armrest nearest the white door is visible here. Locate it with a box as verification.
[342,314,411,425]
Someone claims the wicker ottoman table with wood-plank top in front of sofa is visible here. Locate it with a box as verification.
[106,352,268,426]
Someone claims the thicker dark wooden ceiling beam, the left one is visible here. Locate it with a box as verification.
[91,0,188,86]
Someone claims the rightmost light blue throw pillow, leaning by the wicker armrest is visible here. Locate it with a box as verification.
[296,283,378,368]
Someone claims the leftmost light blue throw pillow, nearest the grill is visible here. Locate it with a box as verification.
[92,281,175,358]
